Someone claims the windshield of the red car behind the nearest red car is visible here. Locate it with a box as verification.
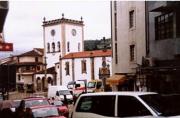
[25,99,49,108]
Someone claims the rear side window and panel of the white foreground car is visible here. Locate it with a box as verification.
[73,95,115,118]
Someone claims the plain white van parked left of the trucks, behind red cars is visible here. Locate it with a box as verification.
[48,86,73,102]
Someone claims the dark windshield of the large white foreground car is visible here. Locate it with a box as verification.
[140,94,180,116]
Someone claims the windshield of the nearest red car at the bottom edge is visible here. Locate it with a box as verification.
[32,107,59,118]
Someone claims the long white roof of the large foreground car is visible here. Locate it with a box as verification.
[82,91,157,96]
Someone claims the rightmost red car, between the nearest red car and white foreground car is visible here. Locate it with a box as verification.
[53,100,69,117]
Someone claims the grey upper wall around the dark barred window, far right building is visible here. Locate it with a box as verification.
[148,1,180,60]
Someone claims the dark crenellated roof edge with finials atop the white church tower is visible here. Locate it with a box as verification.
[43,17,84,26]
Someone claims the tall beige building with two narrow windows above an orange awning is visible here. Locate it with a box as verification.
[111,1,146,90]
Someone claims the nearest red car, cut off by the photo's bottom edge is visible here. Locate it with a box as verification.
[31,105,66,118]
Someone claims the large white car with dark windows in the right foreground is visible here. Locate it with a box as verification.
[72,92,180,118]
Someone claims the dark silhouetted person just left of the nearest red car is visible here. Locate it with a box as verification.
[15,100,25,118]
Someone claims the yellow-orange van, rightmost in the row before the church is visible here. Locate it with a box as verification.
[87,79,103,93]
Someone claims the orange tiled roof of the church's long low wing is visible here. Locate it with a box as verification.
[62,50,112,59]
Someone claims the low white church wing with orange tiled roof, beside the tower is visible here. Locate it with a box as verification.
[55,50,112,85]
